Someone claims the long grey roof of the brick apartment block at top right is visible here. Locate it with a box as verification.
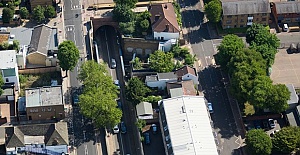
[221,0,271,15]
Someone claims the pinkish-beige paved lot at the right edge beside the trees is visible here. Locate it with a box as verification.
[271,49,300,87]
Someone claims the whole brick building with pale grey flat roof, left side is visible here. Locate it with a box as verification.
[25,86,65,120]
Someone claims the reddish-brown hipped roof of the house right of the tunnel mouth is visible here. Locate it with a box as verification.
[149,3,180,33]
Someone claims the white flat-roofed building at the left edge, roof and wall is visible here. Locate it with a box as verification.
[0,50,20,90]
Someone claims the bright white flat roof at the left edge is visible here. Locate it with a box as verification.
[0,50,17,69]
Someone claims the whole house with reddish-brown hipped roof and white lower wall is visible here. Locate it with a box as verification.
[149,3,180,40]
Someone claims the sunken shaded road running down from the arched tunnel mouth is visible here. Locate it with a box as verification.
[95,26,142,155]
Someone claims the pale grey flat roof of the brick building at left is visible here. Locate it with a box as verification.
[25,86,63,107]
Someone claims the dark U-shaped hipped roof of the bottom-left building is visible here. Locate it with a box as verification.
[5,122,69,148]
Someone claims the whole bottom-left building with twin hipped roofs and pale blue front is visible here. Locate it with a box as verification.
[0,122,69,155]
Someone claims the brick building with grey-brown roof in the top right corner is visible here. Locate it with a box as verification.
[271,0,300,26]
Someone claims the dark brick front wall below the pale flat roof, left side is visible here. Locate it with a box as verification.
[26,105,65,120]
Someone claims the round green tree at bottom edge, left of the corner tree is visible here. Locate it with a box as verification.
[246,129,272,155]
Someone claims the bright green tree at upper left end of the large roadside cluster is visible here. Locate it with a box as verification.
[215,34,245,69]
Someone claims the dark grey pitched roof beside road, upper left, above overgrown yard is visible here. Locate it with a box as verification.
[28,24,58,56]
